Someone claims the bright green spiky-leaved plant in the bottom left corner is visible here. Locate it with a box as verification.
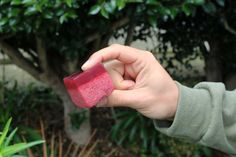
[0,118,44,157]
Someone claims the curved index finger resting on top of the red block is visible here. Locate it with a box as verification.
[82,44,141,70]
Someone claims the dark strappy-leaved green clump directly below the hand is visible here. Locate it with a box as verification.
[111,110,157,155]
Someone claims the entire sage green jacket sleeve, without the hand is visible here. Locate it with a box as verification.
[154,82,236,156]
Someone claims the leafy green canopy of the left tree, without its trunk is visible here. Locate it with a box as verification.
[0,0,204,77]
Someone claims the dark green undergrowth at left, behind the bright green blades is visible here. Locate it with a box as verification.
[0,82,60,151]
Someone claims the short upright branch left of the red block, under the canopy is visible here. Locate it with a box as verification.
[36,37,49,71]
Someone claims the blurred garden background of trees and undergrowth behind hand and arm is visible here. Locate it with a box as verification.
[0,0,236,157]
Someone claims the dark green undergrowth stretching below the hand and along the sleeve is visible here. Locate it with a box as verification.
[111,109,212,157]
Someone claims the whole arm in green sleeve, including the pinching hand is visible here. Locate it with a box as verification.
[82,45,236,155]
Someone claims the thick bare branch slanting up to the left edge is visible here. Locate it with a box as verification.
[0,41,40,80]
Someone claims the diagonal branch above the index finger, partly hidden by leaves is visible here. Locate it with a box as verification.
[85,17,129,44]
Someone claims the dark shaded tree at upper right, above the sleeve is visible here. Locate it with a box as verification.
[158,0,236,88]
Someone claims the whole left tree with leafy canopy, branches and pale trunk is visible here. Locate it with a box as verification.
[0,0,204,143]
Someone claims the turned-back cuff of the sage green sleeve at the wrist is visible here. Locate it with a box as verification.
[154,82,211,142]
